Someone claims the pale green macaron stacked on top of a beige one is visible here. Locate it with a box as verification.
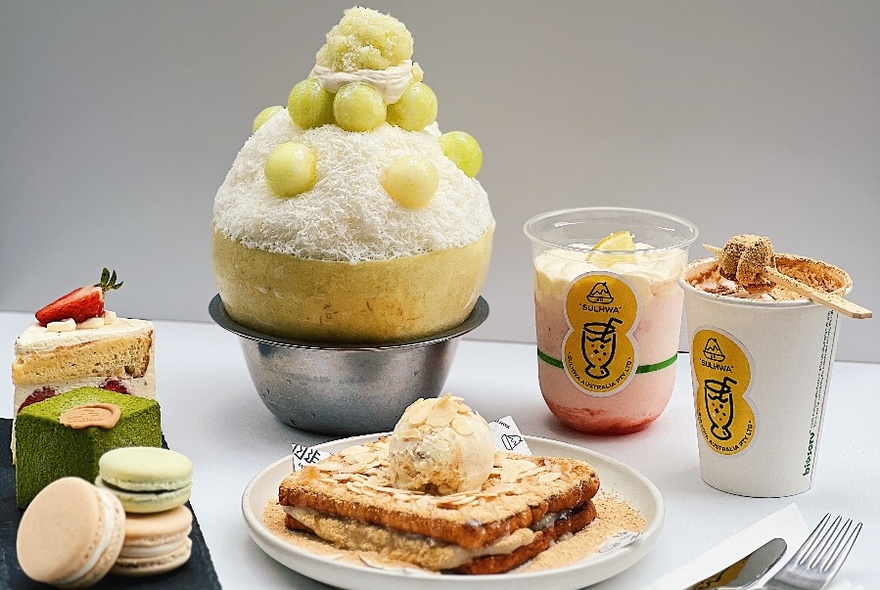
[95,447,192,513]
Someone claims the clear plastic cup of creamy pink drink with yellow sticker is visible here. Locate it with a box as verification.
[525,208,697,435]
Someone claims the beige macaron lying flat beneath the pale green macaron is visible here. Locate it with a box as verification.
[110,506,192,576]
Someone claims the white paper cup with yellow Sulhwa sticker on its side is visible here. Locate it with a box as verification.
[680,257,852,497]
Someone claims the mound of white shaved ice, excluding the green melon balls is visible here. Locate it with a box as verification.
[214,109,495,263]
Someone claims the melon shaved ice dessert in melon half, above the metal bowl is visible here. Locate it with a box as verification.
[213,8,495,343]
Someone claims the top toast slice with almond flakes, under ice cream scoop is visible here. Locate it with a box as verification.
[278,439,599,560]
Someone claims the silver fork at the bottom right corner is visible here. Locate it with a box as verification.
[756,513,862,590]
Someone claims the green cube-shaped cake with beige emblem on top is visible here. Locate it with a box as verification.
[15,387,162,508]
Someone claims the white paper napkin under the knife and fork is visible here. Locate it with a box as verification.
[645,504,864,590]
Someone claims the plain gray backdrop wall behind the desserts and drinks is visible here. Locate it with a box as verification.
[0,0,880,362]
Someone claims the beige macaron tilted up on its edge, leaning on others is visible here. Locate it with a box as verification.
[15,477,125,588]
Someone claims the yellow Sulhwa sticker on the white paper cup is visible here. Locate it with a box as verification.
[691,329,755,455]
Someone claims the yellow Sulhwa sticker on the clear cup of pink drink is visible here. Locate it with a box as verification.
[562,271,640,396]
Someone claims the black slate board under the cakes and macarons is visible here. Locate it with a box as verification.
[0,418,220,590]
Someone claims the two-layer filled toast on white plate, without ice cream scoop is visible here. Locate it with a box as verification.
[279,438,599,574]
